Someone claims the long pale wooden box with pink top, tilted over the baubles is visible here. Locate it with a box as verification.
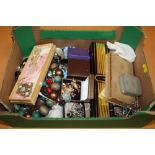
[9,43,56,105]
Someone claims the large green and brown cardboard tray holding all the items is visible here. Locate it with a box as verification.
[0,27,155,128]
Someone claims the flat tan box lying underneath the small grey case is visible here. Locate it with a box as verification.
[106,53,135,105]
